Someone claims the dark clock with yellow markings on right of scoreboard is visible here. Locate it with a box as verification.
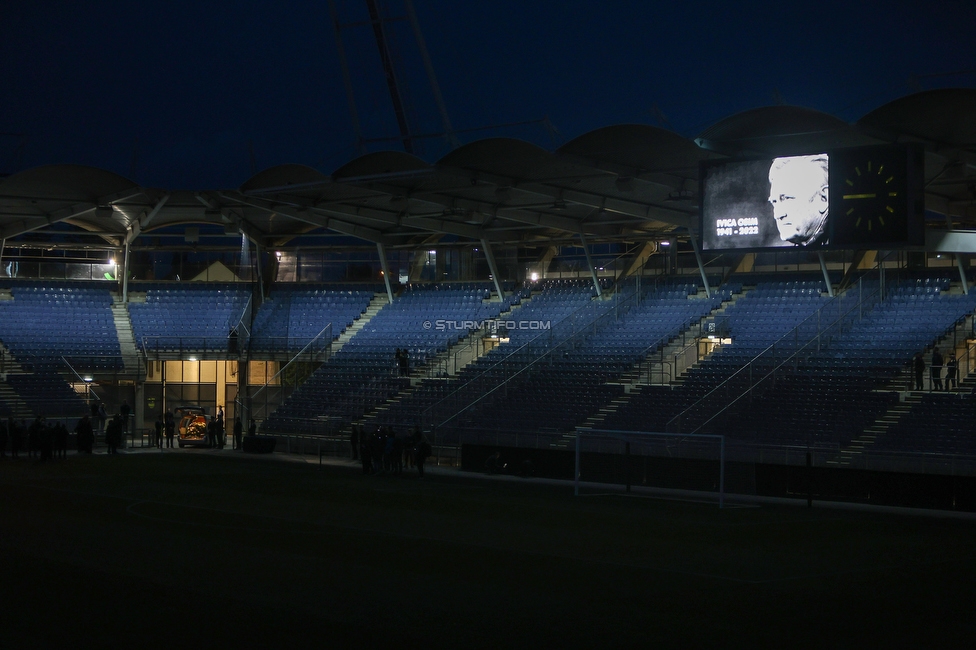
[830,147,907,245]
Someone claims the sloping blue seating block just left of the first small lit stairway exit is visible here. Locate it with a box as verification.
[262,283,508,432]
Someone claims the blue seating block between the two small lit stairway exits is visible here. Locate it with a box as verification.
[370,281,722,439]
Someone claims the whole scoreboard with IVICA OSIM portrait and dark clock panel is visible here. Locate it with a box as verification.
[699,145,925,251]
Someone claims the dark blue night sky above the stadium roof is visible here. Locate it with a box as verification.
[0,0,976,189]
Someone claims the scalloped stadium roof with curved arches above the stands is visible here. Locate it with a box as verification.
[0,89,976,248]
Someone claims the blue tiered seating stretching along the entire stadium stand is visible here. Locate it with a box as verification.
[0,273,976,476]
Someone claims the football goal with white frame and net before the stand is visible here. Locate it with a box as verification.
[574,429,725,508]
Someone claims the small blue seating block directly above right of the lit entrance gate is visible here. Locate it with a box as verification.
[251,285,374,352]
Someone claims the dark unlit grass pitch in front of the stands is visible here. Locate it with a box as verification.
[0,452,976,648]
